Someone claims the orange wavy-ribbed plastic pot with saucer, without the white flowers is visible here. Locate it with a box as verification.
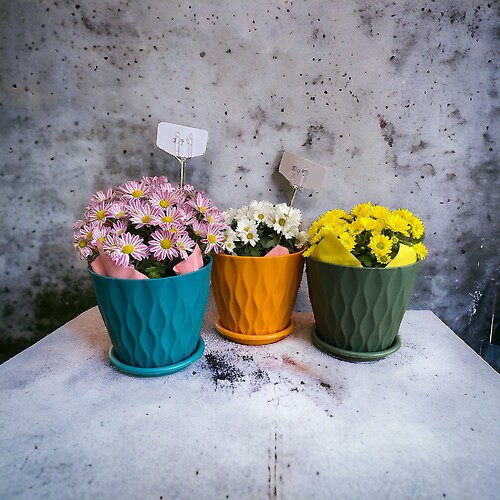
[212,251,304,345]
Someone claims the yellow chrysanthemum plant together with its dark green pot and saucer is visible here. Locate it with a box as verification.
[304,202,427,361]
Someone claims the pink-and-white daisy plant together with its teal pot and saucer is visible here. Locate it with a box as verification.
[73,177,225,376]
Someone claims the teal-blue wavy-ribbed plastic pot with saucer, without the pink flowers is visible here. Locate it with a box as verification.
[89,257,212,376]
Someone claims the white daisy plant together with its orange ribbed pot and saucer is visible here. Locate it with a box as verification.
[212,201,306,345]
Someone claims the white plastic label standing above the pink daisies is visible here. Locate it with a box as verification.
[156,122,208,158]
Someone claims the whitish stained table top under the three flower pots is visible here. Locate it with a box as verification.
[0,308,500,499]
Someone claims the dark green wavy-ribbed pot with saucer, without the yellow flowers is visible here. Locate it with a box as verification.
[306,257,419,361]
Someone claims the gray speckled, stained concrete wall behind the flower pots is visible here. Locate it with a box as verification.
[0,0,500,356]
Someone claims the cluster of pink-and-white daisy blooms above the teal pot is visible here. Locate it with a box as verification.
[73,176,227,278]
